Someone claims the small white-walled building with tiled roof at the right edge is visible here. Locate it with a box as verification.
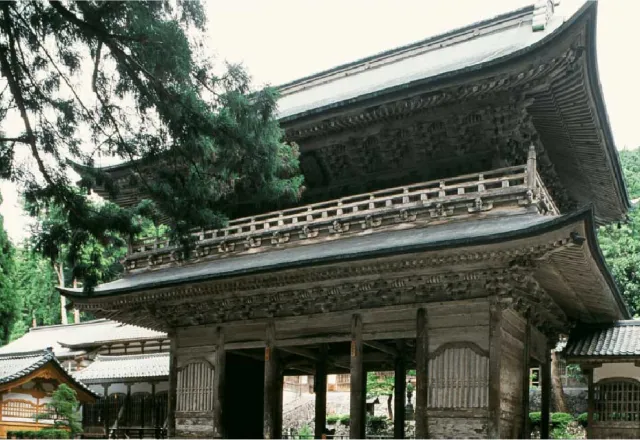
[564,320,640,438]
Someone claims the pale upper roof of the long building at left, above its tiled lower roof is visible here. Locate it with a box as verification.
[0,319,167,358]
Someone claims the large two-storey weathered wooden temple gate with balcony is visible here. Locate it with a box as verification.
[61,0,630,438]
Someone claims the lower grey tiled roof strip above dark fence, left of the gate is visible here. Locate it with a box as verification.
[76,353,169,382]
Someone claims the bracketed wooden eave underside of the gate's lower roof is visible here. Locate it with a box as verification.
[63,210,626,331]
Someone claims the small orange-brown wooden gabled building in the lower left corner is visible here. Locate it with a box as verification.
[0,349,100,438]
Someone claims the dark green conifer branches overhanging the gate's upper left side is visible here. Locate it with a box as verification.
[0,0,303,289]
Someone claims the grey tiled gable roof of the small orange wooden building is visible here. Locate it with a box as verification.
[0,348,100,398]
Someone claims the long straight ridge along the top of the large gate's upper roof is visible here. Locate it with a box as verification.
[275,4,534,95]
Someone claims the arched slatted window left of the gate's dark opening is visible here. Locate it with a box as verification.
[176,361,213,412]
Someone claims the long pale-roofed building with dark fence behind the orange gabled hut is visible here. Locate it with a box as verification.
[0,319,169,437]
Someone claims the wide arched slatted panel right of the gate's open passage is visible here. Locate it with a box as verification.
[429,342,489,409]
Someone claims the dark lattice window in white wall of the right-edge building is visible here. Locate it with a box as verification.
[593,378,640,422]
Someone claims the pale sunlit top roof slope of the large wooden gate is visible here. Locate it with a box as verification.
[278,1,564,121]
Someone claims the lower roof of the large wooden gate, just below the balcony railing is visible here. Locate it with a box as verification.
[60,209,629,323]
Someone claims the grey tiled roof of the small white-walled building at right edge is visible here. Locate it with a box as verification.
[564,320,640,358]
